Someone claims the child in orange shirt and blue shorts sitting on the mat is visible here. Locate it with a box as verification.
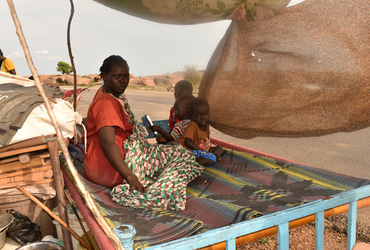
[179,97,224,166]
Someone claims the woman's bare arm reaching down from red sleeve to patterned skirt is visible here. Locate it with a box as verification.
[99,127,146,193]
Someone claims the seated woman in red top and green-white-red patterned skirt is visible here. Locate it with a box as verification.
[84,56,203,210]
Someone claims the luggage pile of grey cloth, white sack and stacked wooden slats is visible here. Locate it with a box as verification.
[0,79,83,234]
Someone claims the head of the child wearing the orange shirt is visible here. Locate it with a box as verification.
[190,97,210,129]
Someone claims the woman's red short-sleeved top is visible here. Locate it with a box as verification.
[84,89,132,188]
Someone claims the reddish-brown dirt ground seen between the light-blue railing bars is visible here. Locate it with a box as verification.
[237,214,370,250]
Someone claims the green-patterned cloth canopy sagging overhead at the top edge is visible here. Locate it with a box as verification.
[94,0,290,24]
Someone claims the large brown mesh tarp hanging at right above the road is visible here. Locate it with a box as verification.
[199,0,370,138]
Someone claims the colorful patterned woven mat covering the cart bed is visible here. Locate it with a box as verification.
[62,142,370,249]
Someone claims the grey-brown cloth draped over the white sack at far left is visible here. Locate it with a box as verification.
[0,83,63,146]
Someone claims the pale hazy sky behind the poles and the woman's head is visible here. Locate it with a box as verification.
[0,0,301,76]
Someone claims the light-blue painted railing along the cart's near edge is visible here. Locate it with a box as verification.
[148,185,370,250]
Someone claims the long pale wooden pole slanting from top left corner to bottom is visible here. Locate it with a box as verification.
[7,0,125,250]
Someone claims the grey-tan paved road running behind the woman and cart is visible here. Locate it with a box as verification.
[77,89,370,223]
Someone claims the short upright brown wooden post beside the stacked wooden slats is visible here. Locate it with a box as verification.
[48,141,73,249]
